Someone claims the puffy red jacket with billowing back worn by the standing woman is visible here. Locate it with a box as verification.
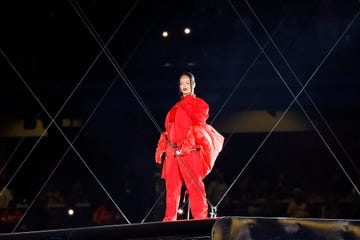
[155,95,224,178]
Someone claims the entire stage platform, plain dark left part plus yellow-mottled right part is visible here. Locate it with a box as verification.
[0,216,360,240]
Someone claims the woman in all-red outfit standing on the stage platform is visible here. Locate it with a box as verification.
[155,72,224,221]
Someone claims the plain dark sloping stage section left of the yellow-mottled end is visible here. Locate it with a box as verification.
[0,219,217,240]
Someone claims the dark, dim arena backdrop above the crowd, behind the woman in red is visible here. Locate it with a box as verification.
[0,0,360,232]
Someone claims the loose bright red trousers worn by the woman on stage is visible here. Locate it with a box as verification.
[163,151,208,221]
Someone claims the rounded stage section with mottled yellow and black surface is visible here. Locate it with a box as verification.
[211,217,360,240]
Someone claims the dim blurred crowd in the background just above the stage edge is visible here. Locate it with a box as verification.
[0,165,360,232]
